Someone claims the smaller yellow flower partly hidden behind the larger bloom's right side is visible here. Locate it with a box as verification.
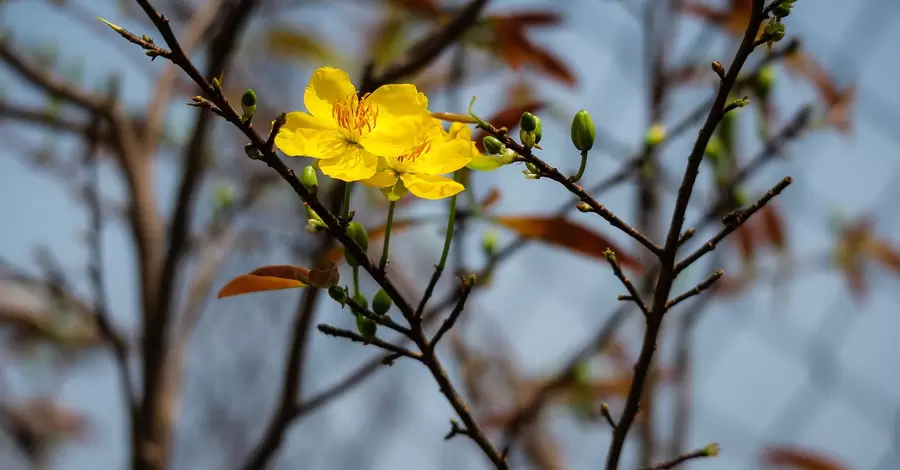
[363,117,478,199]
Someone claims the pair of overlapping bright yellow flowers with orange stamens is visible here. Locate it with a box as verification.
[275,67,479,201]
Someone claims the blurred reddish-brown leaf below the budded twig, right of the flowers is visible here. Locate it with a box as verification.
[492,216,643,270]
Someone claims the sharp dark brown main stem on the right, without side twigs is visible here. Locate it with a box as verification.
[606,0,765,470]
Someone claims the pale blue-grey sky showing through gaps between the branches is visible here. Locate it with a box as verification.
[0,0,900,470]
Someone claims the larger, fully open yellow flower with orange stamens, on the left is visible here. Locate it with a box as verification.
[275,67,428,181]
